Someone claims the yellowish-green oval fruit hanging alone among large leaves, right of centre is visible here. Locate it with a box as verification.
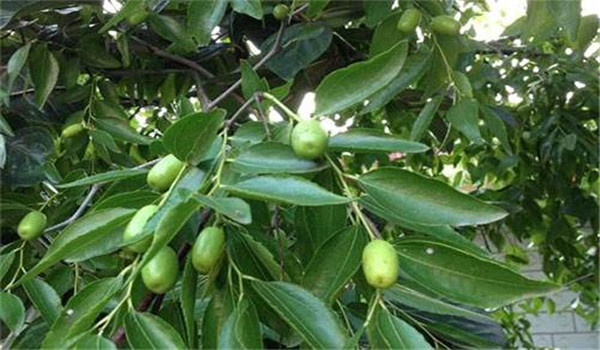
[362,239,398,289]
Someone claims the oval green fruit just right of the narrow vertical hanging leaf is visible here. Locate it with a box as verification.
[192,227,225,273]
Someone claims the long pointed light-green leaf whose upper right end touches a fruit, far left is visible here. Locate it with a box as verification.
[20,208,135,282]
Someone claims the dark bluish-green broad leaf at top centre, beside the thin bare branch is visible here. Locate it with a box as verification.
[261,23,333,81]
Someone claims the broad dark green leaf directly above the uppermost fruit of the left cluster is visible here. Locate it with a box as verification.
[162,109,226,165]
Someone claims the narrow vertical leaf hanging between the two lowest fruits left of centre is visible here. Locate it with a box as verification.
[180,254,198,349]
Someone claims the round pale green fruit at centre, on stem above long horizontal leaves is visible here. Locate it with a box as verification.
[292,120,328,159]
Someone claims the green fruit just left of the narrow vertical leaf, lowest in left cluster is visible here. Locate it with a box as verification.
[142,247,179,294]
